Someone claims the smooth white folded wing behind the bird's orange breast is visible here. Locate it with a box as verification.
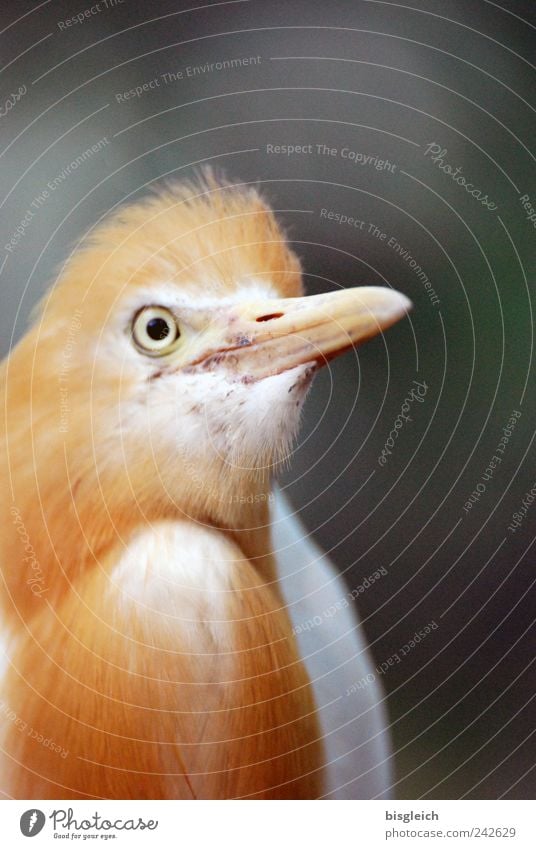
[272,489,392,799]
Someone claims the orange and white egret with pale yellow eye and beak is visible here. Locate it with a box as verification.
[0,170,411,799]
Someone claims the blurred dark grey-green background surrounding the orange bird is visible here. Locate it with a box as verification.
[0,0,536,798]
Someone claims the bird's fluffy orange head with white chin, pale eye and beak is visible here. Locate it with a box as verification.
[2,174,409,540]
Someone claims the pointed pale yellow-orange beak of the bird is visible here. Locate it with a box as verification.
[198,286,411,380]
